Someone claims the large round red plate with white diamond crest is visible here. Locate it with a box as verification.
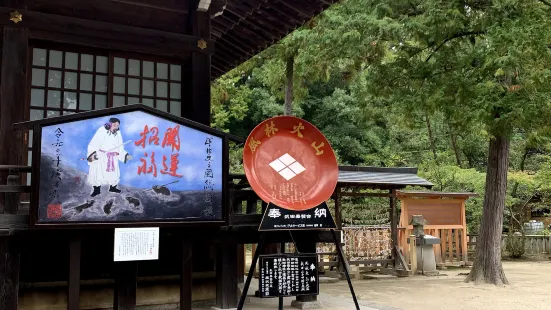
[243,116,339,211]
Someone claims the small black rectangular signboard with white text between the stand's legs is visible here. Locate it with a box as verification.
[258,254,319,298]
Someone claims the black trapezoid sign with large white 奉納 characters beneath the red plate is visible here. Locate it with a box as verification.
[258,202,337,231]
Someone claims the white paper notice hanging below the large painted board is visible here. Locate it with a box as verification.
[114,227,159,262]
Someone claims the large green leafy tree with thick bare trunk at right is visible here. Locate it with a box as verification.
[358,0,551,284]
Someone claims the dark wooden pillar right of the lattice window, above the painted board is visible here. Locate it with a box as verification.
[182,0,211,126]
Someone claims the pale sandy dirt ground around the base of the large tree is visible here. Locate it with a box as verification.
[320,261,551,310]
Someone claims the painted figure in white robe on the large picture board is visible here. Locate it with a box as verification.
[87,118,132,197]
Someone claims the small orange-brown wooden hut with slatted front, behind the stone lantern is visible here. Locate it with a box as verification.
[396,191,477,266]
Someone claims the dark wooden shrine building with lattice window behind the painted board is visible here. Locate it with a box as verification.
[0,0,335,310]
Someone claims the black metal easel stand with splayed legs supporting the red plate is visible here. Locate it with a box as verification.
[237,204,360,310]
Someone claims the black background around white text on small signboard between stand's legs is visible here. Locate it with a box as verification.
[258,254,319,298]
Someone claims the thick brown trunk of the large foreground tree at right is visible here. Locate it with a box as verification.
[465,135,510,285]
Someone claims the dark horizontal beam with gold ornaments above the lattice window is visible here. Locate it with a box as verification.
[0,7,214,55]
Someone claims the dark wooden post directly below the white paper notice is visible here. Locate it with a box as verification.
[113,262,138,310]
